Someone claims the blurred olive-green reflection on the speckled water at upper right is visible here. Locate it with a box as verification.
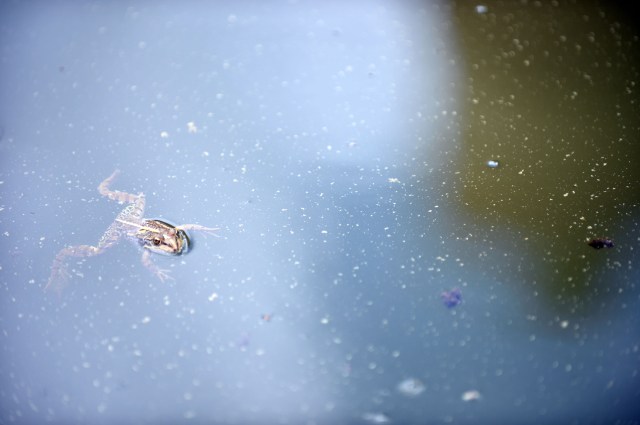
[455,1,640,311]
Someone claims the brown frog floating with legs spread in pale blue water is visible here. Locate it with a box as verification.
[45,169,220,293]
